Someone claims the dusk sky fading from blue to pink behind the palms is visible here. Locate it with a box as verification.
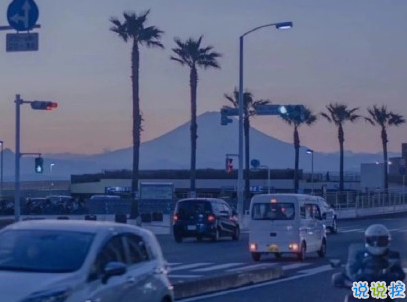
[0,0,407,154]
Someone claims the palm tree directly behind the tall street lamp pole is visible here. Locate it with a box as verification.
[223,88,270,204]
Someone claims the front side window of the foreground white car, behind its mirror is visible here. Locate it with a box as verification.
[90,235,127,280]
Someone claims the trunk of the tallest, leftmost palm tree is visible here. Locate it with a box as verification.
[130,40,141,217]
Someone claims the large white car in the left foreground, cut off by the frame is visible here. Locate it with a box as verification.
[0,220,174,302]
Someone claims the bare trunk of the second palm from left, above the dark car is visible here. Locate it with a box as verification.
[189,66,198,194]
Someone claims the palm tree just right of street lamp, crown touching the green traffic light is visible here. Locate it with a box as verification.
[280,107,317,193]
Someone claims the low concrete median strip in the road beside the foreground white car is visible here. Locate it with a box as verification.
[173,264,284,300]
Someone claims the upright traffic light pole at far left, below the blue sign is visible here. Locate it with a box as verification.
[14,94,22,222]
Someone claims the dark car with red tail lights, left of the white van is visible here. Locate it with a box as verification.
[173,198,240,242]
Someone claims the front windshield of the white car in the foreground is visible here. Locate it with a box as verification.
[0,230,94,273]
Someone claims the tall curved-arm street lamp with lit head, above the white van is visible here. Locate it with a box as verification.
[237,22,293,217]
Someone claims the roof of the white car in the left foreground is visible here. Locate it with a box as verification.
[4,219,149,233]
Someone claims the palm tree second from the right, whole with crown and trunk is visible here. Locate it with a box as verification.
[321,103,360,191]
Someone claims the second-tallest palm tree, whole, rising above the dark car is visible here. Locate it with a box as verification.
[171,36,222,194]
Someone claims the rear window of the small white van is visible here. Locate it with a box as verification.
[252,202,295,220]
